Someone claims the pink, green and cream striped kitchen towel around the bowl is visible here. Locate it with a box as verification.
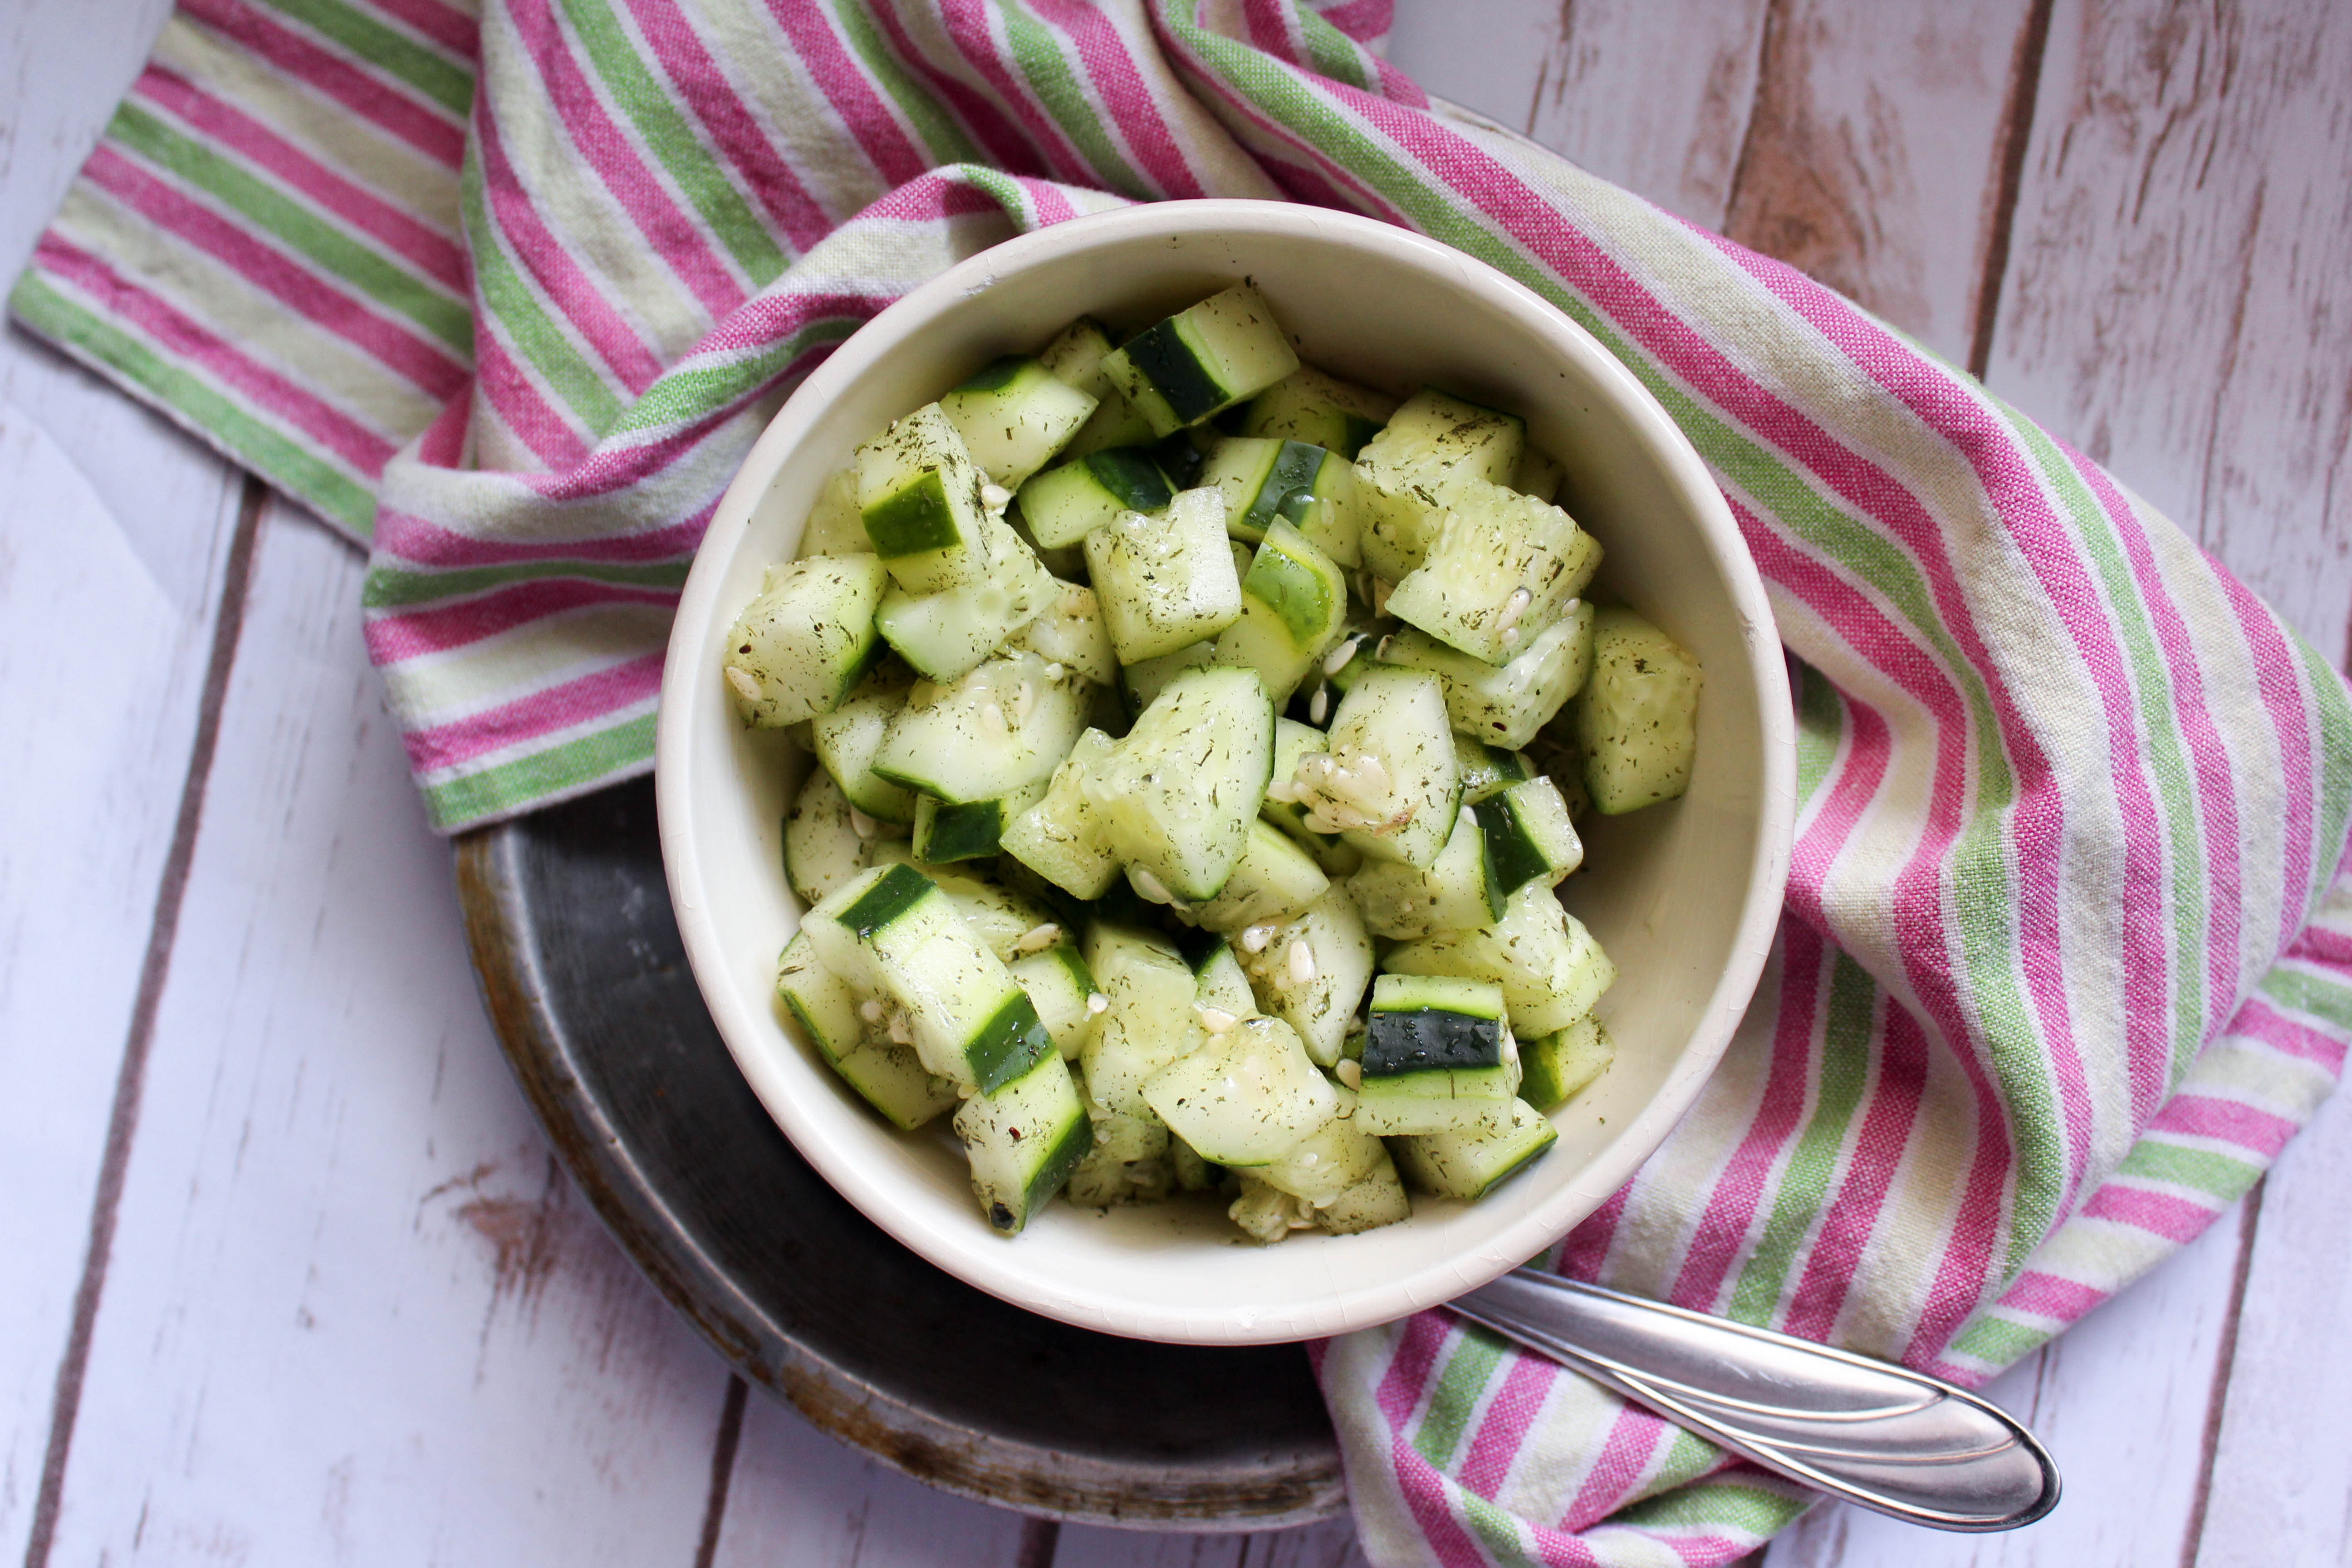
[12,0,2352,1563]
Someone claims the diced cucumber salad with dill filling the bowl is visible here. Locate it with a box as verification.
[725,282,1700,1241]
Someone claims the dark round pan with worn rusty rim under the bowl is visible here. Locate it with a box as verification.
[456,783,1345,1530]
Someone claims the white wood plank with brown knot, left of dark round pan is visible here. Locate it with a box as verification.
[34,513,752,1568]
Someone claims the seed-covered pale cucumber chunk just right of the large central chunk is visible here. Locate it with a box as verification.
[1284,665,1460,870]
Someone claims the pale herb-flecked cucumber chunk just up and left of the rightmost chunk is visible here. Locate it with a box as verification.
[1385,480,1602,665]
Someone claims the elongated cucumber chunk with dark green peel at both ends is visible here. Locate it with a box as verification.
[802,865,1054,1093]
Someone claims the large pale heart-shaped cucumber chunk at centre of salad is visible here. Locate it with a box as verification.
[1084,670,1279,903]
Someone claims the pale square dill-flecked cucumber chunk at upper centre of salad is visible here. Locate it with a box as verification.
[1087,489,1242,665]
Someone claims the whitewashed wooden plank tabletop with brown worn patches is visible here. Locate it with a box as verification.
[0,0,2352,1568]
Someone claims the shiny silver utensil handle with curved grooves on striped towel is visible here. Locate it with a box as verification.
[1449,1269,2058,1530]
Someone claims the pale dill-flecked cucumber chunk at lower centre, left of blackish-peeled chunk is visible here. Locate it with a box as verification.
[1143,1018,1338,1166]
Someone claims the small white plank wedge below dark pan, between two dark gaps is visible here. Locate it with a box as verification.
[708,1394,1039,1568]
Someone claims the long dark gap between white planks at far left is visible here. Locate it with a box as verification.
[24,475,270,1568]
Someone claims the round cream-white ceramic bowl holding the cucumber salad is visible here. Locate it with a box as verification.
[659,202,1794,1345]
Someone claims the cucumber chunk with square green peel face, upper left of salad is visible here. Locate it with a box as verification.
[858,402,995,593]
